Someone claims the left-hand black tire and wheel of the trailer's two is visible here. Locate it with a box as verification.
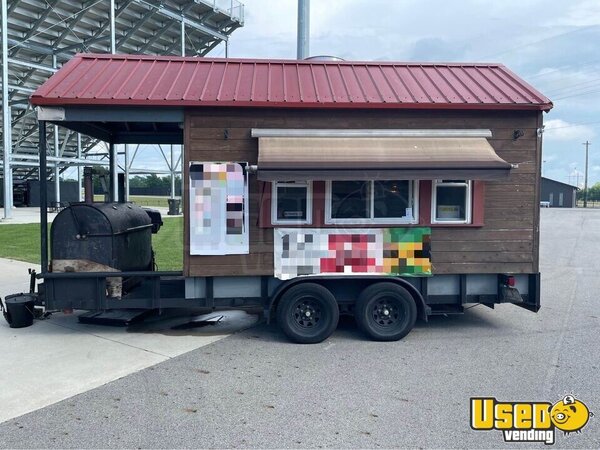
[277,283,340,344]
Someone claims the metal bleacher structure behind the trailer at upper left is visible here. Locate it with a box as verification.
[0,0,244,218]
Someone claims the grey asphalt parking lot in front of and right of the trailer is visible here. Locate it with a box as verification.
[0,209,600,448]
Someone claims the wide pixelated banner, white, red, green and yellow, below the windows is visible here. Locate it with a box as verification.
[274,228,431,280]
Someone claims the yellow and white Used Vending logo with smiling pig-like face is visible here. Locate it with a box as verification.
[471,395,594,445]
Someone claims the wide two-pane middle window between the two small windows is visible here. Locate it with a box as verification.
[325,180,418,224]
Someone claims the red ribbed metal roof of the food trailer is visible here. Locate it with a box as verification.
[31,54,552,111]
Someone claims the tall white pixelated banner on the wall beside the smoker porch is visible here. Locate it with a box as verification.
[190,162,249,255]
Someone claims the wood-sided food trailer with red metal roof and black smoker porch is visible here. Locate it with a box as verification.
[1,54,552,343]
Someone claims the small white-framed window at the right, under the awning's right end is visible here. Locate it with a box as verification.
[431,180,472,224]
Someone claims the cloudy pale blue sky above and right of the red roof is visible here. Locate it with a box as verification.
[210,0,600,184]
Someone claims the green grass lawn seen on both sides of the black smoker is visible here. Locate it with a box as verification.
[0,217,183,270]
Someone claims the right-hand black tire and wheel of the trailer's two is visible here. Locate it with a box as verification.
[354,282,417,341]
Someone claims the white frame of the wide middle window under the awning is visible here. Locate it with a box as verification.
[325,180,420,225]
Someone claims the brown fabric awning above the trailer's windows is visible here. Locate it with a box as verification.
[258,137,512,181]
